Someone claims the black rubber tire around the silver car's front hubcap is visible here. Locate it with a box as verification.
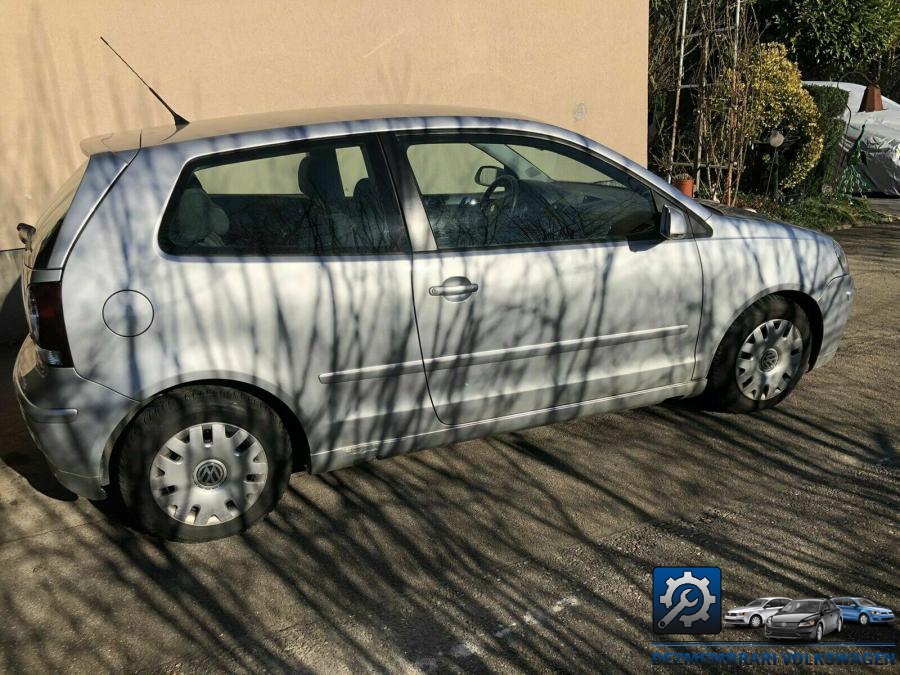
[704,295,812,413]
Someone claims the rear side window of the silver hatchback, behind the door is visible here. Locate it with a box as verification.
[159,139,409,256]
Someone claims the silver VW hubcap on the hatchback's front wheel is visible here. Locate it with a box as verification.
[734,319,803,401]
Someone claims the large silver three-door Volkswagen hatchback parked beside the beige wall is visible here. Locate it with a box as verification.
[14,107,854,541]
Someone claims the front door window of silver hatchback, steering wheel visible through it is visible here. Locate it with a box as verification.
[401,134,659,249]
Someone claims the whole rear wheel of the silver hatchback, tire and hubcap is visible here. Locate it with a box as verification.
[113,386,291,541]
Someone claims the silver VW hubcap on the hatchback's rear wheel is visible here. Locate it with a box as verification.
[150,422,269,526]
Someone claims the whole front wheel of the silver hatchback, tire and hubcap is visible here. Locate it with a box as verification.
[706,295,812,412]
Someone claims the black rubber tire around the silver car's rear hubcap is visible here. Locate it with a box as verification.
[110,385,292,542]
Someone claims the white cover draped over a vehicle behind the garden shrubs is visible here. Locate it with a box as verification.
[805,81,900,196]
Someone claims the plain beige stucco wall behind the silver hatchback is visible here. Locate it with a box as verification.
[0,0,648,250]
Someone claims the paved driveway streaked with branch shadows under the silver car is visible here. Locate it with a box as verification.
[0,224,900,672]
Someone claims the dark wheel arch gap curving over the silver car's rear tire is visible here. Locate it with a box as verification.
[102,377,311,484]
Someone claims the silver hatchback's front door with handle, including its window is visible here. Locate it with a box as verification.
[393,132,702,424]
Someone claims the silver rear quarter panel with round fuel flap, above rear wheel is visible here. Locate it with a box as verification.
[63,139,435,462]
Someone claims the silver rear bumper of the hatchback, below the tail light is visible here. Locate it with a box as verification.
[13,338,138,499]
